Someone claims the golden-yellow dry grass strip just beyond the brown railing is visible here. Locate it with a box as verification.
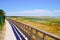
[14,19,60,36]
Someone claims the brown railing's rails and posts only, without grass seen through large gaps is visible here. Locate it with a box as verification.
[7,20,60,40]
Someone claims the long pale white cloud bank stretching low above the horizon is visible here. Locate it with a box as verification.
[7,9,60,16]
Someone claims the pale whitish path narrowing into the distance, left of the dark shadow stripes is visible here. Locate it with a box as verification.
[4,20,16,40]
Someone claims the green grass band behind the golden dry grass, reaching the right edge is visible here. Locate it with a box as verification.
[23,18,60,26]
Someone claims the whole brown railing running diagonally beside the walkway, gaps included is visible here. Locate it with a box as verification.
[7,20,60,40]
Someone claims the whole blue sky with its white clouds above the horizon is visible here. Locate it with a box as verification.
[0,0,60,16]
